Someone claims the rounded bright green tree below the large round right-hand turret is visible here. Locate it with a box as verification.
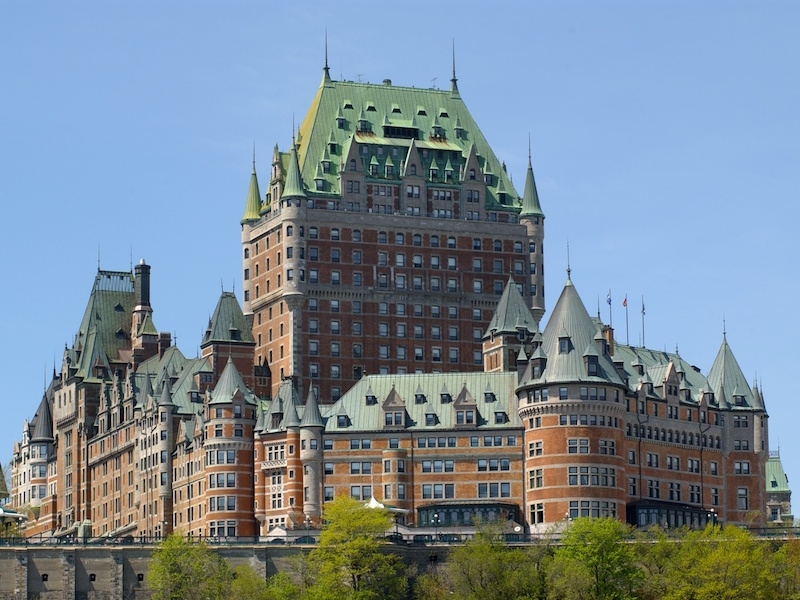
[548,518,642,600]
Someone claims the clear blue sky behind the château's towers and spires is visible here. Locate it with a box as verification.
[0,0,800,504]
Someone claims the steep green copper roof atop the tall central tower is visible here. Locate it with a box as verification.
[294,79,519,211]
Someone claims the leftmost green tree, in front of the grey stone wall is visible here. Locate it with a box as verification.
[147,533,232,600]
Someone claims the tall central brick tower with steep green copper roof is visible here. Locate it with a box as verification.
[242,61,544,403]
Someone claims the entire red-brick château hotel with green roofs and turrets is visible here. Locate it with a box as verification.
[9,62,791,537]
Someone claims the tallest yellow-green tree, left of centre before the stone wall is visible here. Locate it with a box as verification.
[305,496,408,600]
